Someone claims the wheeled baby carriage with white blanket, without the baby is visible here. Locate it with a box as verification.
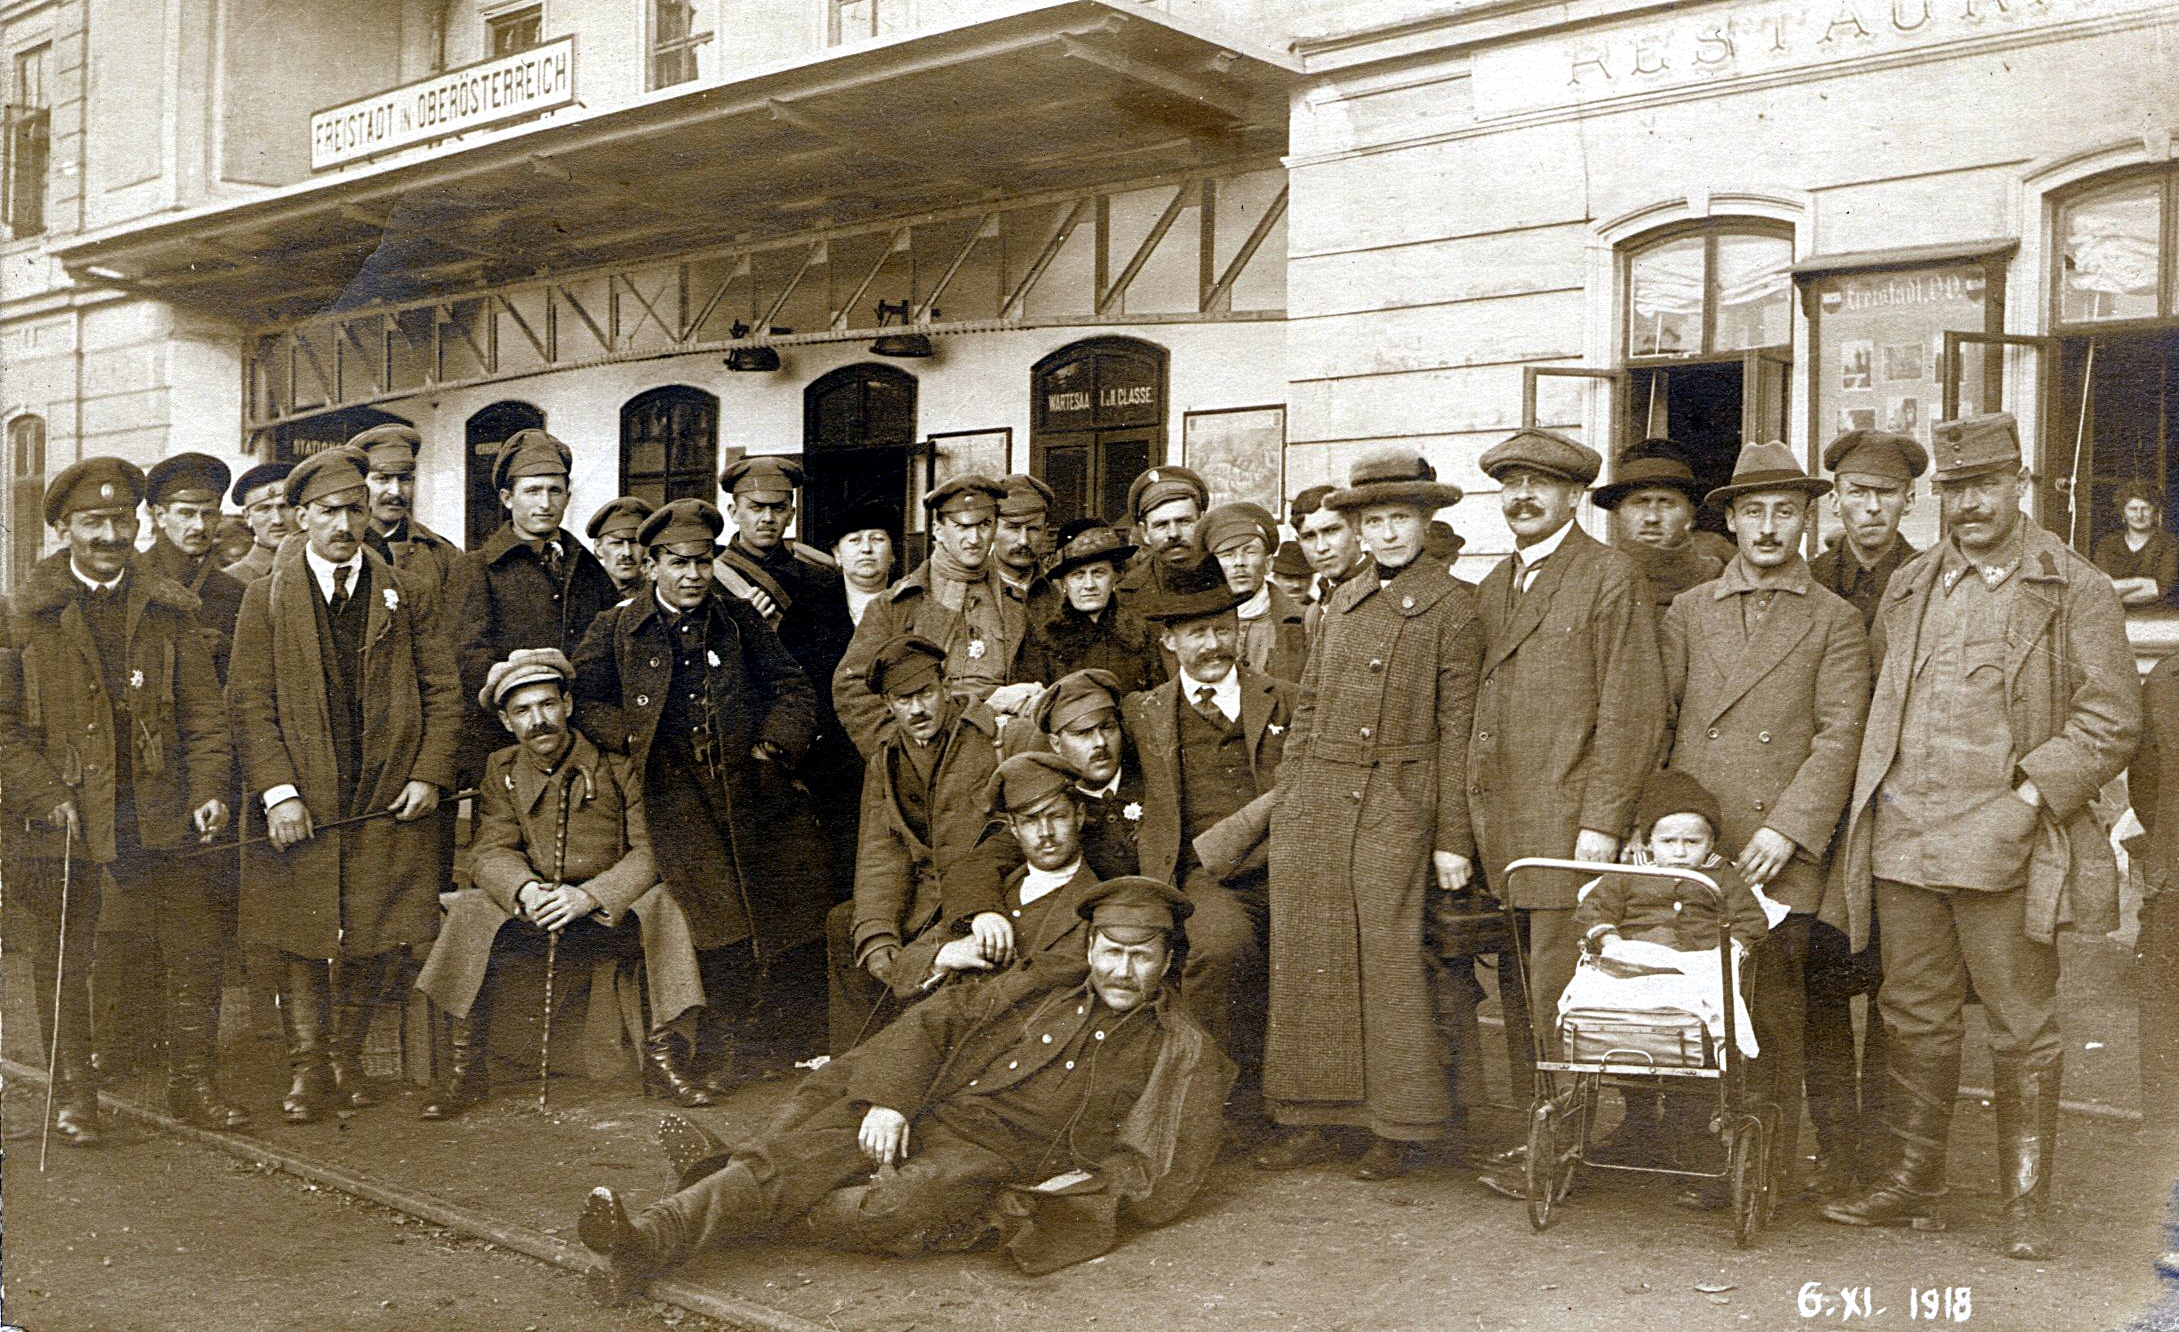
[1506,857,1778,1247]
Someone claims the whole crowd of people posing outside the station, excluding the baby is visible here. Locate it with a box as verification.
[0,401,2140,1280]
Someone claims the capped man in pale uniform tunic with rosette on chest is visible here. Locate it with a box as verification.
[832,473,1028,759]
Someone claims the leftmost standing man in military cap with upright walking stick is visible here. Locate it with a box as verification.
[0,458,248,1147]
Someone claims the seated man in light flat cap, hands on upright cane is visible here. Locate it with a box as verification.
[416,647,710,1118]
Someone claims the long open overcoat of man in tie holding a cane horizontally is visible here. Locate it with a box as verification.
[227,538,462,957]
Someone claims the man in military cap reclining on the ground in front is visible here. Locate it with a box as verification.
[577,879,1233,1297]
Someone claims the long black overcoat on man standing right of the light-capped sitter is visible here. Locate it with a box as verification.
[575,584,835,957]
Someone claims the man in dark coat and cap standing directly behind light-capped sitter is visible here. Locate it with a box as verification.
[447,429,621,772]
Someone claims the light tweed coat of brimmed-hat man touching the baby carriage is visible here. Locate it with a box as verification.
[1658,556,1870,911]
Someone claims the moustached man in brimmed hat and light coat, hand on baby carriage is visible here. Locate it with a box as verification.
[1660,443,1870,1190]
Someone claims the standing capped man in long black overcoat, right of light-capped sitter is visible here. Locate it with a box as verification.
[573,499,832,1088]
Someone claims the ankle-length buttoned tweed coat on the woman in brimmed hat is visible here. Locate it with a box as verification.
[1264,560,1484,1138]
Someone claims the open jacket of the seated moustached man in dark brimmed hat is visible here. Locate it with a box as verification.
[1120,665,1301,887]
